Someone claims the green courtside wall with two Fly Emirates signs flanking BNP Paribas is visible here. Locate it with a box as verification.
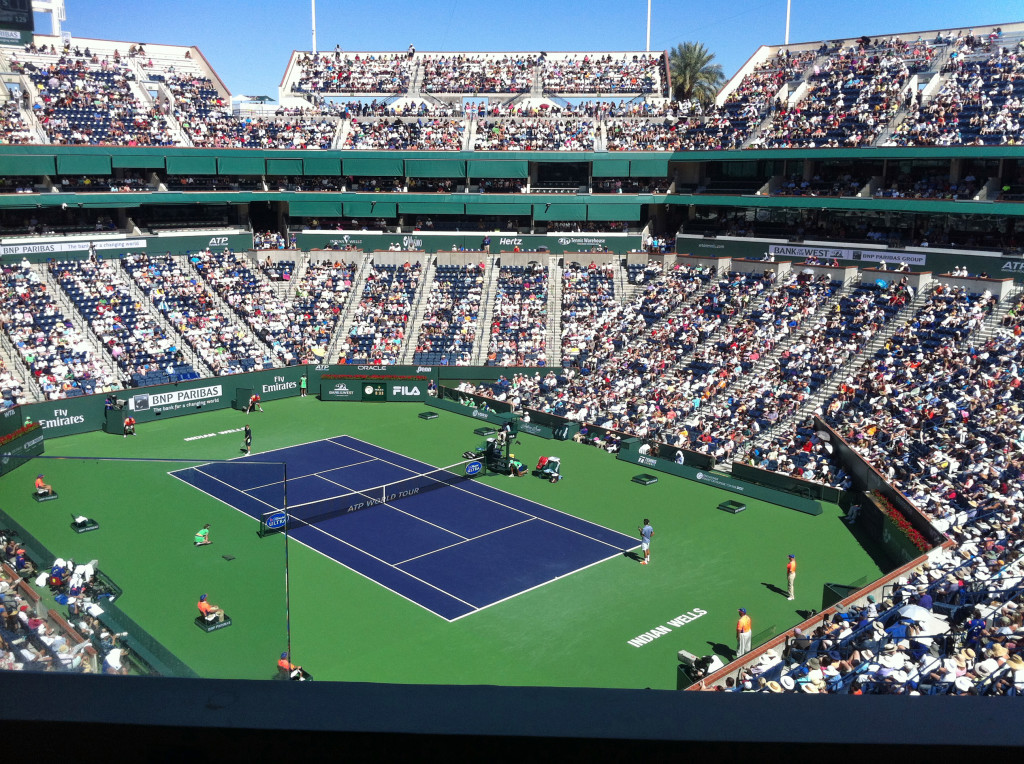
[22,366,306,437]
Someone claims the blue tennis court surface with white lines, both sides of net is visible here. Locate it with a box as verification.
[171,435,638,621]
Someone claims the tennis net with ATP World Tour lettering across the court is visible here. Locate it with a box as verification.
[288,459,484,530]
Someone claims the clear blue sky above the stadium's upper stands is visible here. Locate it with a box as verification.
[36,0,1024,97]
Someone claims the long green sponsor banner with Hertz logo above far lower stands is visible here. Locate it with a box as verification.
[296,230,641,254]
